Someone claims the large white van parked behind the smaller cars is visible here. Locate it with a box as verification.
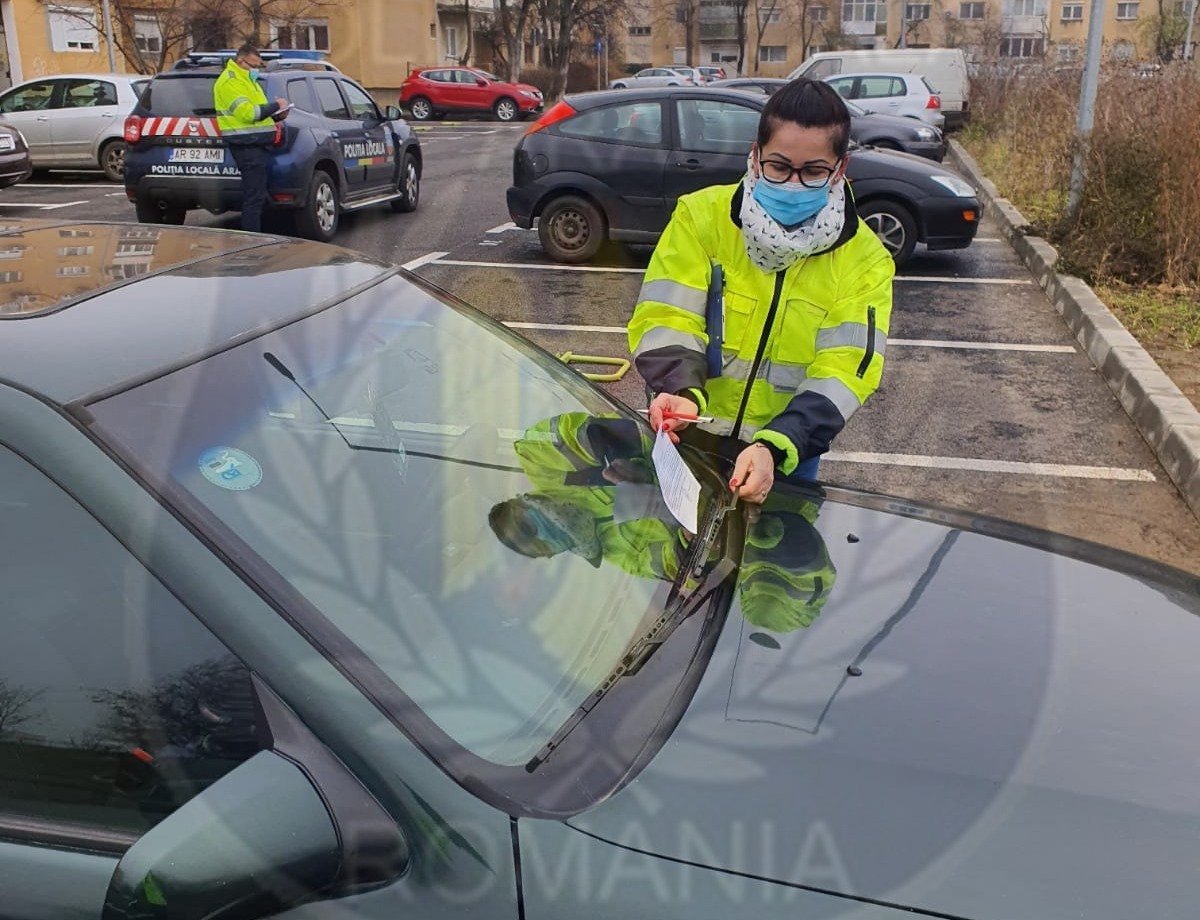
[788,48,971,128]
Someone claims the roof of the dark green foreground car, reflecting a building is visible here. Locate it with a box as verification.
[0,218,395,404]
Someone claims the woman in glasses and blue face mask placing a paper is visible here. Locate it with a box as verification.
[629,78,895,503]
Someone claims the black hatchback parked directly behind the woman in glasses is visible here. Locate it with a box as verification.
[508,86,980,265]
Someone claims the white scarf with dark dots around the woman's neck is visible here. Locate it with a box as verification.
[739,154,846,273]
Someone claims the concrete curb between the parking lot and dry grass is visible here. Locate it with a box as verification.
[950,140,1200,518]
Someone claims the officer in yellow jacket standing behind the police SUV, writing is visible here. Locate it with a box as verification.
[212,44,288,231]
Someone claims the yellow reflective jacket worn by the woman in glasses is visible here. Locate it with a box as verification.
[629,184,895,475]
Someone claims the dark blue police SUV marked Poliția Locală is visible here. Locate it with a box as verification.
[125,55,422,241]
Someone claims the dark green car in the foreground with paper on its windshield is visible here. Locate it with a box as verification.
[0,221,1200,920]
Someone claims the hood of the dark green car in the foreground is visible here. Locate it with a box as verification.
[569,484,1200,920]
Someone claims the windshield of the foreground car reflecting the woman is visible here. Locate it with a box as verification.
[90,277,719,765]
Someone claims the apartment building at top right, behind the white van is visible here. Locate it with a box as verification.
[624,0,1166,77]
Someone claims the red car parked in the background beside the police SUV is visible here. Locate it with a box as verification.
[400,67,542,121]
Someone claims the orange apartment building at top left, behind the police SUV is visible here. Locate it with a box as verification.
[0,0,494,98]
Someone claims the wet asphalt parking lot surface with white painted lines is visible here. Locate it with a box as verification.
[9,121,1200,571]
